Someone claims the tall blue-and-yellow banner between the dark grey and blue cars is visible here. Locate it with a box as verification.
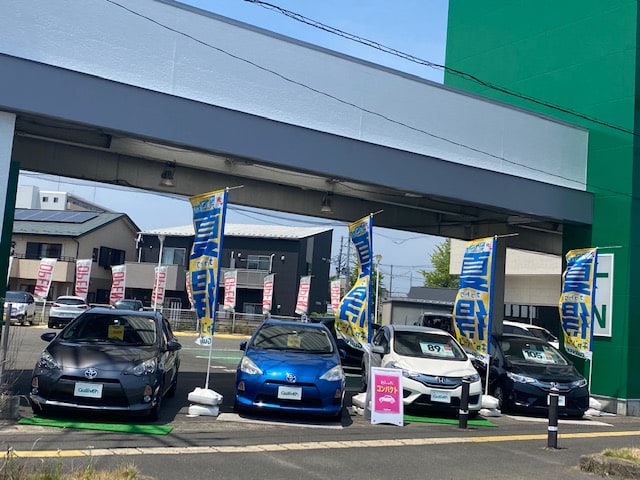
[189,189,228,345]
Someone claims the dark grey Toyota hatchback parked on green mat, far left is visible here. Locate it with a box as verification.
[29,307,181,420]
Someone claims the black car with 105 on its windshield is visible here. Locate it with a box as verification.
[474,334,589,417]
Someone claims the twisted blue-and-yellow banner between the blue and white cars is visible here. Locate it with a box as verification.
[335,215,373,343]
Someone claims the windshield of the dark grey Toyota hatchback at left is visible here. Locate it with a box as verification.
[62,313,157,345]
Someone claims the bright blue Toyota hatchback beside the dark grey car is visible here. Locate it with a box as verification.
[234,319,345,419]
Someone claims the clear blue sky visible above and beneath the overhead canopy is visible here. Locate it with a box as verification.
[20,0,448,294]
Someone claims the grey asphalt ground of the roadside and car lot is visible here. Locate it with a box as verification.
[0,327,640,479]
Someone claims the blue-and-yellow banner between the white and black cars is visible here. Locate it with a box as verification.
[453,237,497,358]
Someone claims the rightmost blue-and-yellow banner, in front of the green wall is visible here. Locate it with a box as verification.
[558,248,598,360]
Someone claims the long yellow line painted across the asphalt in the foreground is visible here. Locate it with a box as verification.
[3,430,640,459]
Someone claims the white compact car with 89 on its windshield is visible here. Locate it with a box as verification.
[362,325,482,416]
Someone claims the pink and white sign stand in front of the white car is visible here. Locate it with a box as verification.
[370,367,404,426]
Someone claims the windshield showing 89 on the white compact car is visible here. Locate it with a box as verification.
[393,331,467,360]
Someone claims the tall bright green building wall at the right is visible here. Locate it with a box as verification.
[444,0,640,415]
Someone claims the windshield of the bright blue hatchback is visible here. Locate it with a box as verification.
[251,324,333,353]
